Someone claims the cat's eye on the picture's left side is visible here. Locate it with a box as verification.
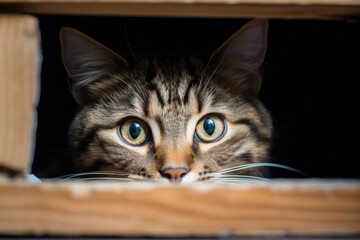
[118,118,150,146]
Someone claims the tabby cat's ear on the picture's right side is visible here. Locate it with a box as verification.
[210,19,268,97]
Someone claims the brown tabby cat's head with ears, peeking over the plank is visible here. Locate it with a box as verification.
[60,20,271,183]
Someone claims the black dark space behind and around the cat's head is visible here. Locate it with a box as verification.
[33,16,360,178]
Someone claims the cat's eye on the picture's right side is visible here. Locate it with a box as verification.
[195,114,226,142]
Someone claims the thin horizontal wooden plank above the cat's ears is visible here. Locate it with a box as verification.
[0,0,360,20]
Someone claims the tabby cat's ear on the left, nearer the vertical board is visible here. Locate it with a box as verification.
[60,27,128,104]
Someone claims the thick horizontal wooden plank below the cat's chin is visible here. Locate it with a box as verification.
[0,180,360,237]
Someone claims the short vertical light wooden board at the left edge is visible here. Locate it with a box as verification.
[0,15,40,174]
